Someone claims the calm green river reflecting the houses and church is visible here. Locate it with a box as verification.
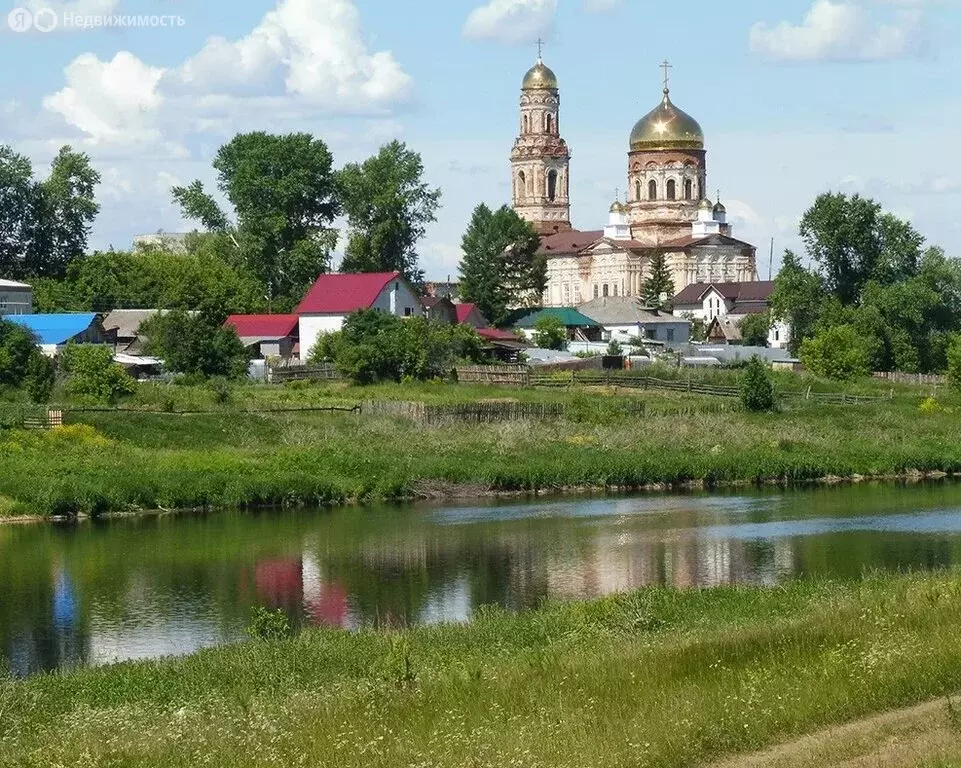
[0,484,961,676]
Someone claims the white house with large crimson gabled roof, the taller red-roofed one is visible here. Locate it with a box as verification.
[296,272,424,360]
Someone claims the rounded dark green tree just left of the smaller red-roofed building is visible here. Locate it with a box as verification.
[140,309,250,379]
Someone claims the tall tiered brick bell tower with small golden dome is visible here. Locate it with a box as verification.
[511,43,571,235]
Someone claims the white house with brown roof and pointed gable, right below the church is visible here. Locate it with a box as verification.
[674,280,791,349]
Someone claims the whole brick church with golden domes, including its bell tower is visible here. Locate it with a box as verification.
[511,55,757,307]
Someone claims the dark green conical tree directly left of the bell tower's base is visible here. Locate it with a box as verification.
[460,204,547,326]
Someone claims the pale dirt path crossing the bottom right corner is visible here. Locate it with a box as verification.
[713,698,961,768]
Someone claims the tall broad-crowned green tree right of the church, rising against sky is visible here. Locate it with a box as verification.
[800,193,924,304]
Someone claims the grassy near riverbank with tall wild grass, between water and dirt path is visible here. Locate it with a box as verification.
[0,573,961,768]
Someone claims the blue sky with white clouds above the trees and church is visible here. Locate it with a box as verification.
[0,0,961,279]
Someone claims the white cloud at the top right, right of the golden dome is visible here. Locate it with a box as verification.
[750,0,923,61]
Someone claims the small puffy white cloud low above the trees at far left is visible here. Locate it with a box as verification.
[43,51,164,143]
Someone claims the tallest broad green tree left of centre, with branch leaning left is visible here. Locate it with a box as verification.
[172,132,341,306]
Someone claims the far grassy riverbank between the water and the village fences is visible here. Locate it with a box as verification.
[0,385,961,517]
